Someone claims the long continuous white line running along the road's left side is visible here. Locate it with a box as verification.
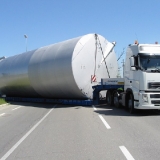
[0,105,56,160]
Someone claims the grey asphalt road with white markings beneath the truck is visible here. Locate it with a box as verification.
[0,103,160,160]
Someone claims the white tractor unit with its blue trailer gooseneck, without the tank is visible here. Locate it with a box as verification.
[93,41,160,114]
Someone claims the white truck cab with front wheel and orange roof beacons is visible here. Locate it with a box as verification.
[122,43,160,112]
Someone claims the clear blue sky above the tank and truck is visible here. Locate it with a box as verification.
[0,0,160,73]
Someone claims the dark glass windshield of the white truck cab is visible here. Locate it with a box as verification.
[139,54,160,72]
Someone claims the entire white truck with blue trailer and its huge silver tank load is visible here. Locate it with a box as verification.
[0,34,160,113]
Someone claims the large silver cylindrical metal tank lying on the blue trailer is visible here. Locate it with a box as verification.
[0,34,118,99]
